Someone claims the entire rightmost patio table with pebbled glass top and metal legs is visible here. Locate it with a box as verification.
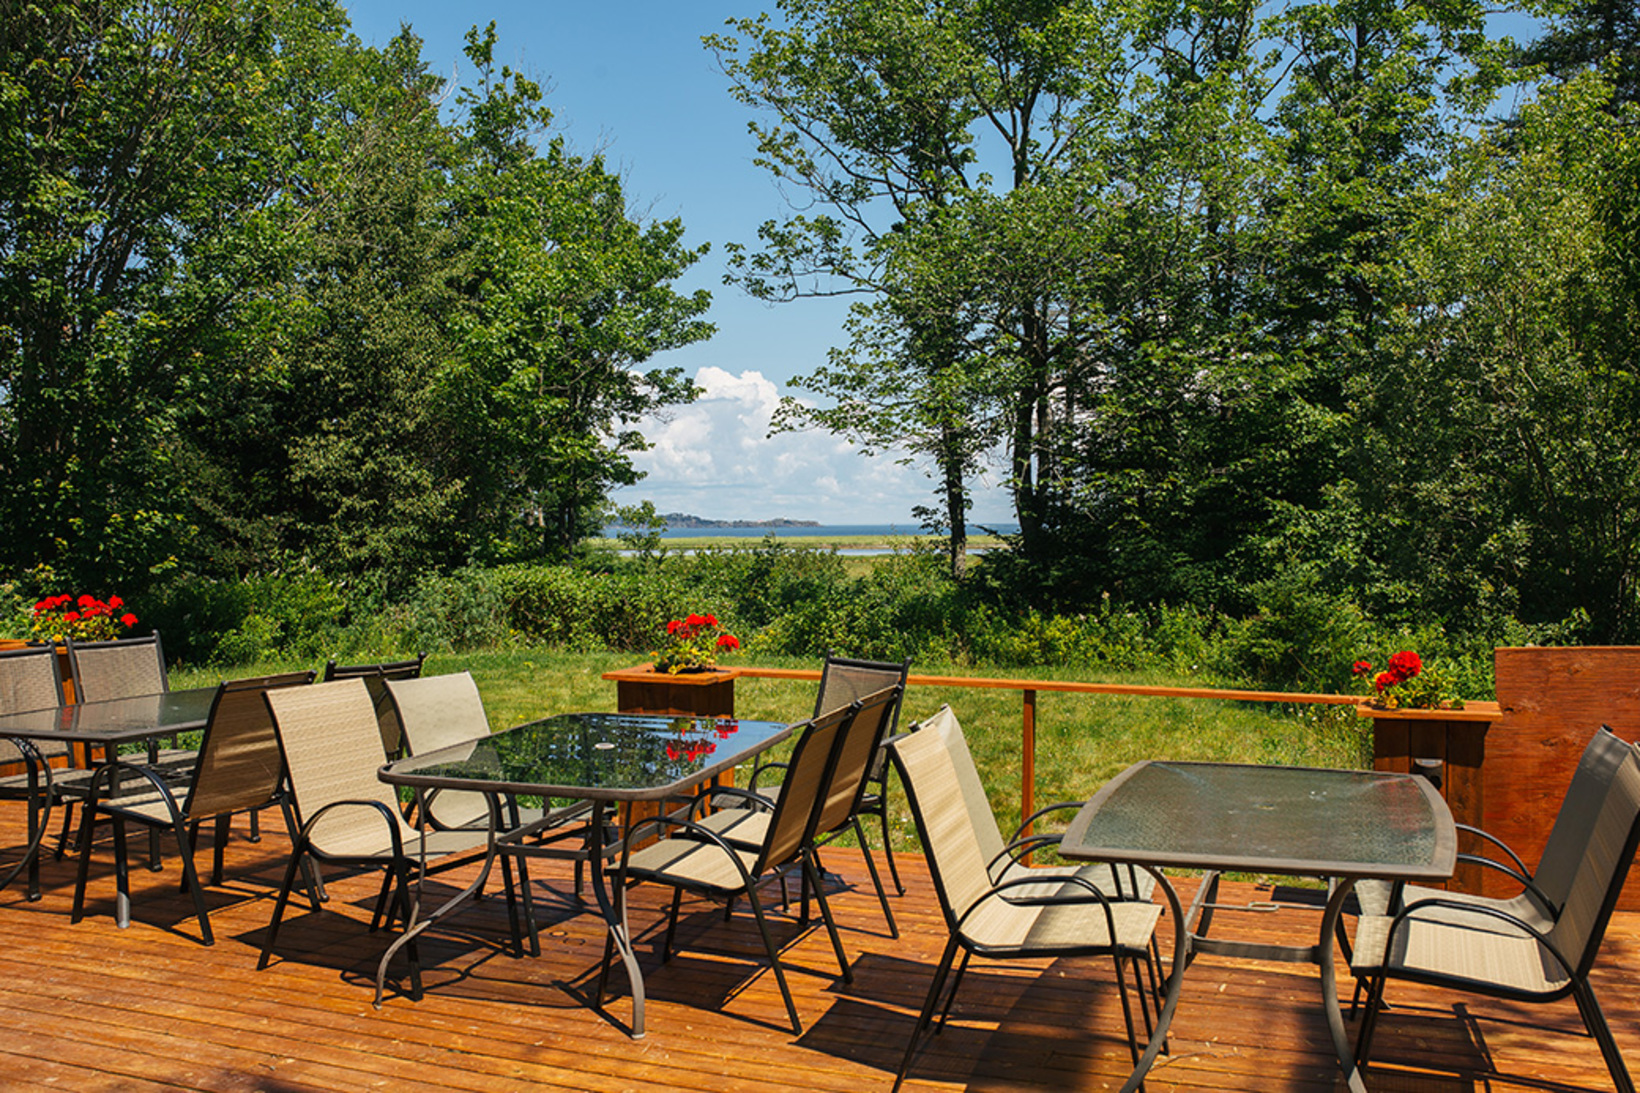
[1059,761,1458,1093]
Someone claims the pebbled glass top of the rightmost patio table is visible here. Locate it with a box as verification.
[1061,761,1456,880]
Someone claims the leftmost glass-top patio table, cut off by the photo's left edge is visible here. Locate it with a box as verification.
[0,688,216,909]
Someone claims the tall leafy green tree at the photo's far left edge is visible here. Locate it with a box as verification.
[0,0,343,588]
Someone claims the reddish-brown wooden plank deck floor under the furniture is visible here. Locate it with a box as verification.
[0,806,1640,1093]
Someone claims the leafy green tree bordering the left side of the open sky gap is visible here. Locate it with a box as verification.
[433,23,713,553]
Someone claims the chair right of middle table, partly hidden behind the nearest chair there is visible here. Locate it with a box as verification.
[694,683,900,937]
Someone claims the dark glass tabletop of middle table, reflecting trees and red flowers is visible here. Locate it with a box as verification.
[382,714,792,799]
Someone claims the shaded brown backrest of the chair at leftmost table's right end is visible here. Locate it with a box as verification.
[184,671,313,819]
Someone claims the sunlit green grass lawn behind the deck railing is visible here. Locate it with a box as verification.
[171,648,1369,847]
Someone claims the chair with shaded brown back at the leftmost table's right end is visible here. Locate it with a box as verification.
[72,671,313,945]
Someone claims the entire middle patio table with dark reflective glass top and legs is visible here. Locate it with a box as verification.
[377,714,792,1039]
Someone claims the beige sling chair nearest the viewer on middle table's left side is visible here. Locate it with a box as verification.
[256,679,535,998]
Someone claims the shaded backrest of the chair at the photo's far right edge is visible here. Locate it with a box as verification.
[1550,727,1640,978]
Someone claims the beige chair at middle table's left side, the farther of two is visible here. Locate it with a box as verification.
[387,671,615,896]
